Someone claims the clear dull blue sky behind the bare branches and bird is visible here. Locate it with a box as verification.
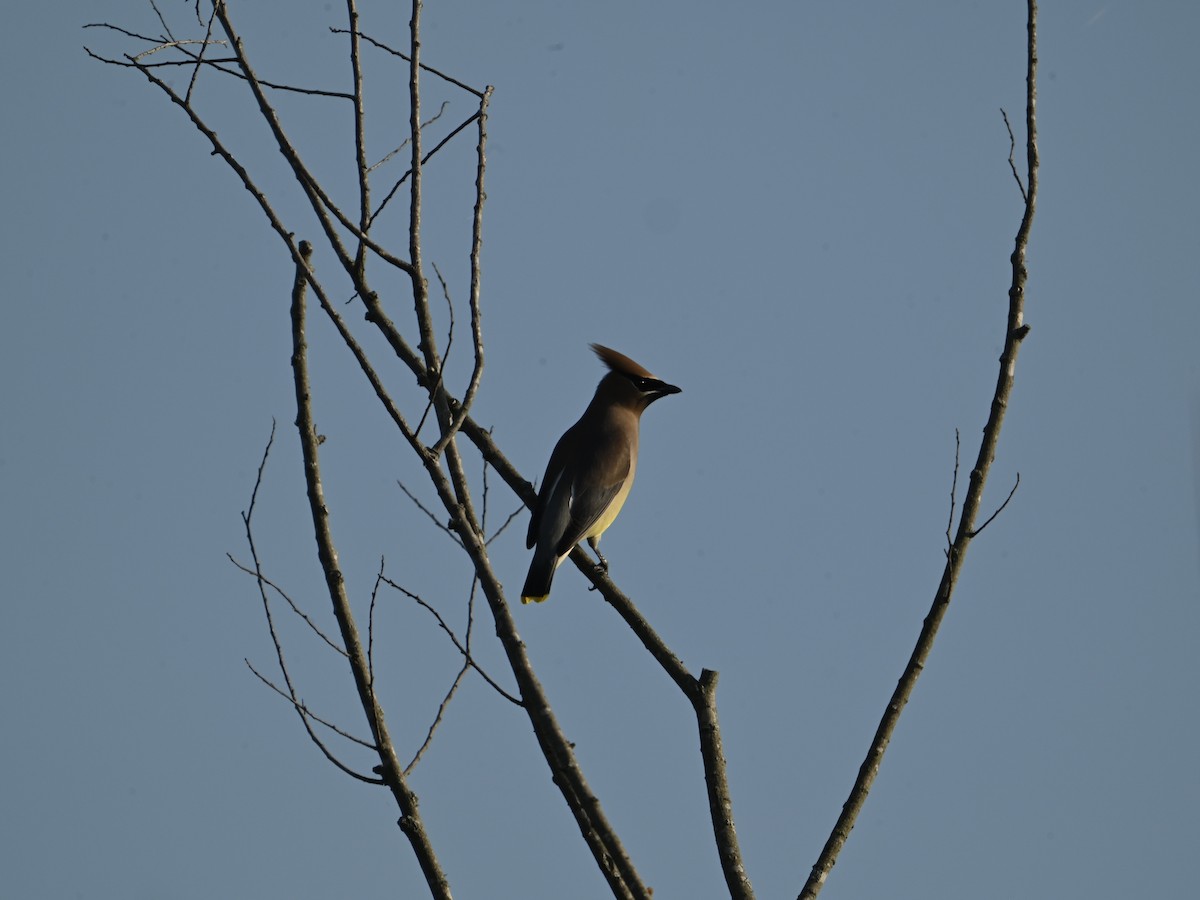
[0,0,1200,900]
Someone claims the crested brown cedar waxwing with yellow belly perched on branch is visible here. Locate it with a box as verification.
[521,343,679,604]
